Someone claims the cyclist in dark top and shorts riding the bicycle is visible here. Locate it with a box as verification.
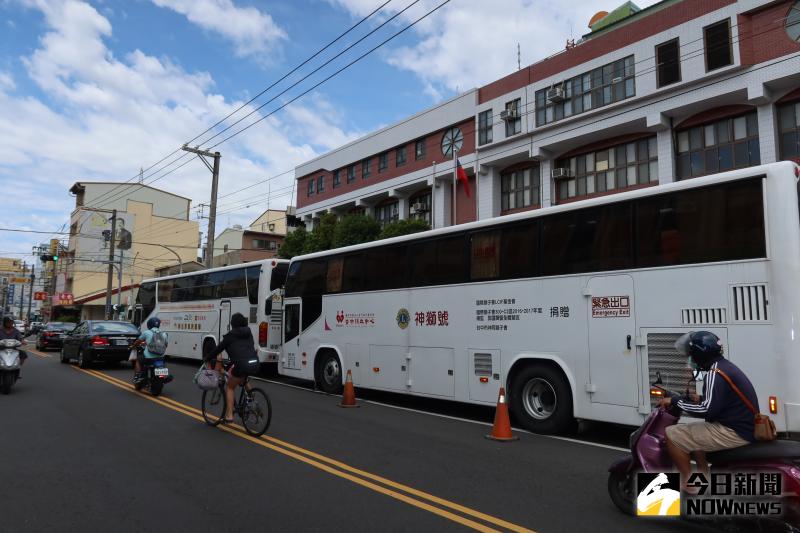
[203,313,259,422]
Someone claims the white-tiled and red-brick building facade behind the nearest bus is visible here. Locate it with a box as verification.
[295,0,800,227]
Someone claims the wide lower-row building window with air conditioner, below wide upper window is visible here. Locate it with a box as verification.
[556,137,658,200]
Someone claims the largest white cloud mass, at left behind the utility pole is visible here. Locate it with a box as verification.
[0,0,354,252]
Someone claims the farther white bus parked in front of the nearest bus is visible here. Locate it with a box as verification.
[130,259,289,363]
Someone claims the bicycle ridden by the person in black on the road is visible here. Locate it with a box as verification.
[202,361,272,437]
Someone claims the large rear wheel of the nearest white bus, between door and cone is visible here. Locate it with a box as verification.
[509,364,574,433]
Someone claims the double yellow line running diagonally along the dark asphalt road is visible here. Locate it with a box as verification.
[72,366,535,533]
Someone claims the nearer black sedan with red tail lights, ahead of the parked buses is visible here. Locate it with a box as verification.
[61,320,139,368]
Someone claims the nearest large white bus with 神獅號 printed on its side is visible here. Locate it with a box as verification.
[278,162,800,432]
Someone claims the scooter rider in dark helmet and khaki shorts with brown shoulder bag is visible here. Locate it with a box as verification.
[659,331,758,489]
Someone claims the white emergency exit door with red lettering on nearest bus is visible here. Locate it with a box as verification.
[586,275,639,407]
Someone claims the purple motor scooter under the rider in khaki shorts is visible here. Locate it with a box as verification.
[608,374,800,533]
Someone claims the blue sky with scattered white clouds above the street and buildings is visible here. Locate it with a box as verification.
[0,0,654,257]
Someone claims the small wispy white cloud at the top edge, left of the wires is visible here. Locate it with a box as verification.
[152,0,287,60]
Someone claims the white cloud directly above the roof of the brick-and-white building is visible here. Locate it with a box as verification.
[329,0,657,98]
